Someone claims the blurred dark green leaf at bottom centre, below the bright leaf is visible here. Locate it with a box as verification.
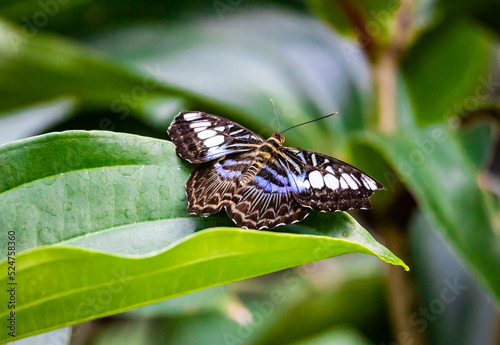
[248,271,388,345]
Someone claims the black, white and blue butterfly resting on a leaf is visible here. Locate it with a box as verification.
[167,111,385,229]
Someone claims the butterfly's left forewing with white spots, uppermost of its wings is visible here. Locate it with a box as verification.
[167,111,263,163]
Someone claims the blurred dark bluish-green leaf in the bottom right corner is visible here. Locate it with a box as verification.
[408,209,496,344]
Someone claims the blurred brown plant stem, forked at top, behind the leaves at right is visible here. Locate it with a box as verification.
[337,0,426,345]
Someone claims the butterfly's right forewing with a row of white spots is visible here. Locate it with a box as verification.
[282,147,385,212]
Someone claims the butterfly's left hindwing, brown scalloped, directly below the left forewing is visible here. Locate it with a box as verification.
[186,153,253,216]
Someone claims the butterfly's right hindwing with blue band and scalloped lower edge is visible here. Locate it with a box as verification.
[226,157,310,229]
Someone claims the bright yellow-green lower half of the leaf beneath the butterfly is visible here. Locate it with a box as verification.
[0,223,406,341]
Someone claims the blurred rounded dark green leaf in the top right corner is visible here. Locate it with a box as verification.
[402,20,493,125]
